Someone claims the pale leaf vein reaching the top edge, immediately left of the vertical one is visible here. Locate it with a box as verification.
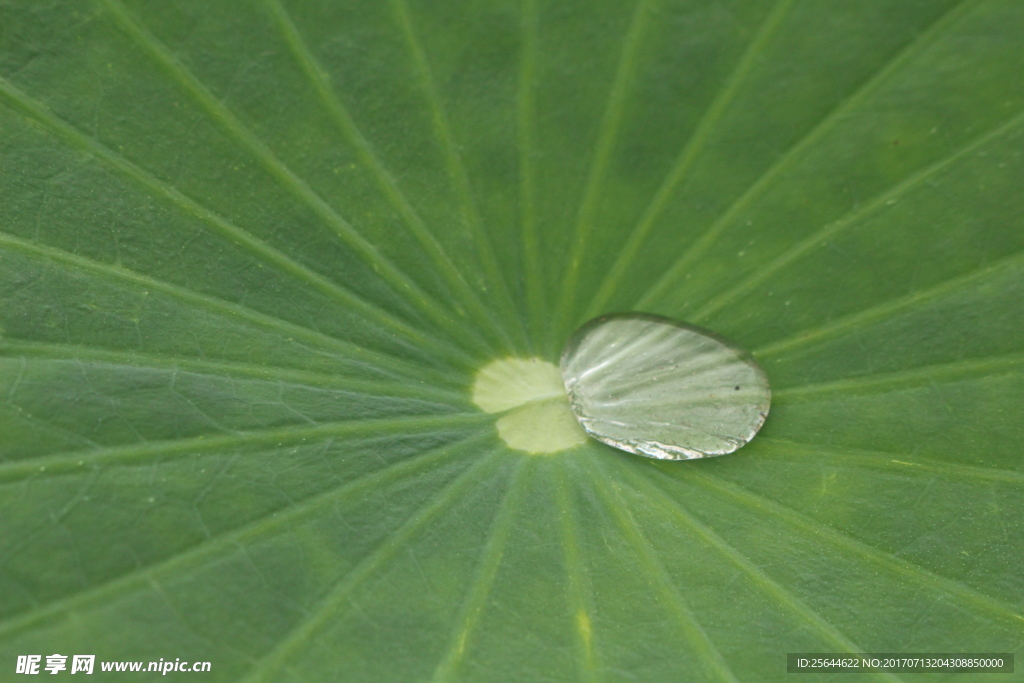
[389,0,526,347]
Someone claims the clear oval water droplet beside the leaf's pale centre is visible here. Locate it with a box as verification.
[561,313,771,460]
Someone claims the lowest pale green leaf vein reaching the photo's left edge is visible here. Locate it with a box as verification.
[0,431,490,637]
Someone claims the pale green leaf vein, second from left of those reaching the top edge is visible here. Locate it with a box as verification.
[265,0,510,350]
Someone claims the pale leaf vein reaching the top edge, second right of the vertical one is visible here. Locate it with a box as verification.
[585,0,794,317]
